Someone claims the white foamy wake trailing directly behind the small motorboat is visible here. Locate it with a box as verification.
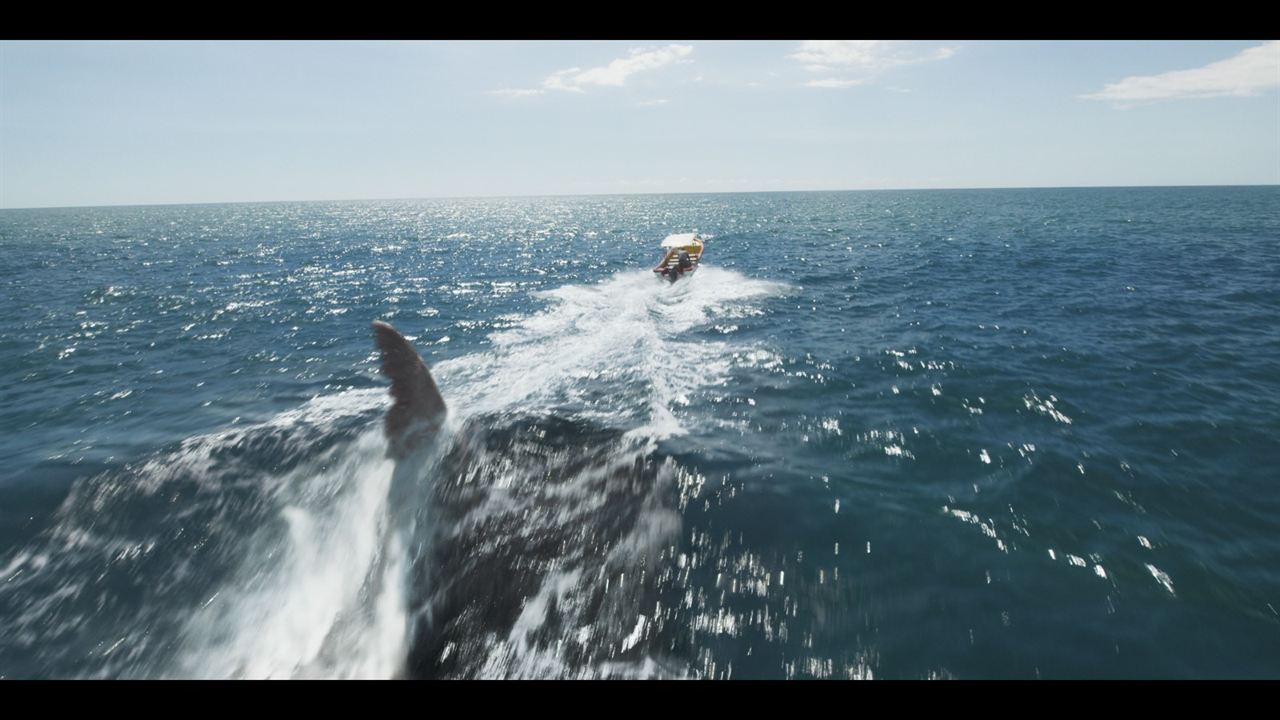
[435,266,786,439]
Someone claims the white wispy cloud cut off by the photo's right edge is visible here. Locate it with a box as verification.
[1080,40,1280,102]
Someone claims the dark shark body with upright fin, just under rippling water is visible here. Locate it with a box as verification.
[372,320,680,678]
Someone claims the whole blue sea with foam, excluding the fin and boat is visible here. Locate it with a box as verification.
[0,187,1280,679]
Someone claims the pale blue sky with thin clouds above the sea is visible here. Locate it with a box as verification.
[0,40,1280,208]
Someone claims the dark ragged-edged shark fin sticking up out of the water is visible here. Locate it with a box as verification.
[374,320,445,457]
